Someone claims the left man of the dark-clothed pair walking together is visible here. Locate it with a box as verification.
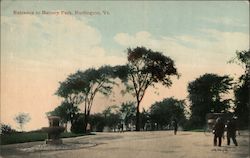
[213,117,225,146]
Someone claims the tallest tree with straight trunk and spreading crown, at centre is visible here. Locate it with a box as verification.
[118,47,179,131]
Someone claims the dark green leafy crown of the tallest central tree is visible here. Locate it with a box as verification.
[128,47,178,86]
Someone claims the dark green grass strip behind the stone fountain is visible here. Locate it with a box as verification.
[0,132,86,145]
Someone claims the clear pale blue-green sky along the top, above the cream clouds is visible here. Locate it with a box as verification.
[2,1,249,53]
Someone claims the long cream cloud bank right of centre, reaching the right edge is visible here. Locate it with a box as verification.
[114,29,249,65]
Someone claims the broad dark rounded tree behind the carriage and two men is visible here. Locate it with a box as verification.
[188,74,233,127]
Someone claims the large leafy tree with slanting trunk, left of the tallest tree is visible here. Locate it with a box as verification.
[56,66,115,132]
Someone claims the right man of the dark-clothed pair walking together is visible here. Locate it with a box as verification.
[227,118,238,146]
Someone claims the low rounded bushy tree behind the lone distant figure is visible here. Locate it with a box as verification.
[150,97,186,128]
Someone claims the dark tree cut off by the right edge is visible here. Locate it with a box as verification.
[230,50,250,127]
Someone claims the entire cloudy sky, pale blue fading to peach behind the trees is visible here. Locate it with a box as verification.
[1,0,249,130]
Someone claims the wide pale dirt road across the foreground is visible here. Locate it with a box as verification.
[1,131,250,158]
